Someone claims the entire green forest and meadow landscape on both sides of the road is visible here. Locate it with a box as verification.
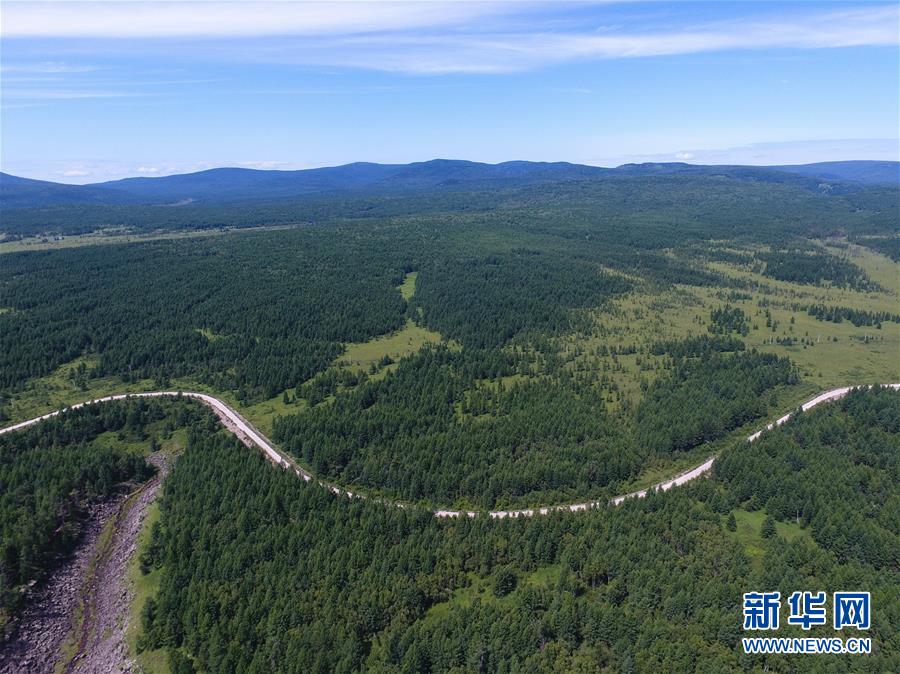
[0,169,900,674]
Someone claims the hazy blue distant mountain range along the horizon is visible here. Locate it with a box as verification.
[0,159,900,208]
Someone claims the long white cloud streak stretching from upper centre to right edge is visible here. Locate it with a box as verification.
[304,5,900,74]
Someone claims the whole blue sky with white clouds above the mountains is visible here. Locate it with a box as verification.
[0,0,900,183]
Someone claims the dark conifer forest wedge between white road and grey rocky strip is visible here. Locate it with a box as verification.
[0,399,215,614]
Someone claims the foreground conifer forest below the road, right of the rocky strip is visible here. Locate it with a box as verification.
[135,390,900,672]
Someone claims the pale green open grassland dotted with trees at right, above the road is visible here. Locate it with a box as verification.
[559,247,900,410]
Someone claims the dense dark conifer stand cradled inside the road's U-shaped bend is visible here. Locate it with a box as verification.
[275,347,797,508]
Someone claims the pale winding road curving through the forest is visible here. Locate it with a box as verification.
[0,384,900,519]
